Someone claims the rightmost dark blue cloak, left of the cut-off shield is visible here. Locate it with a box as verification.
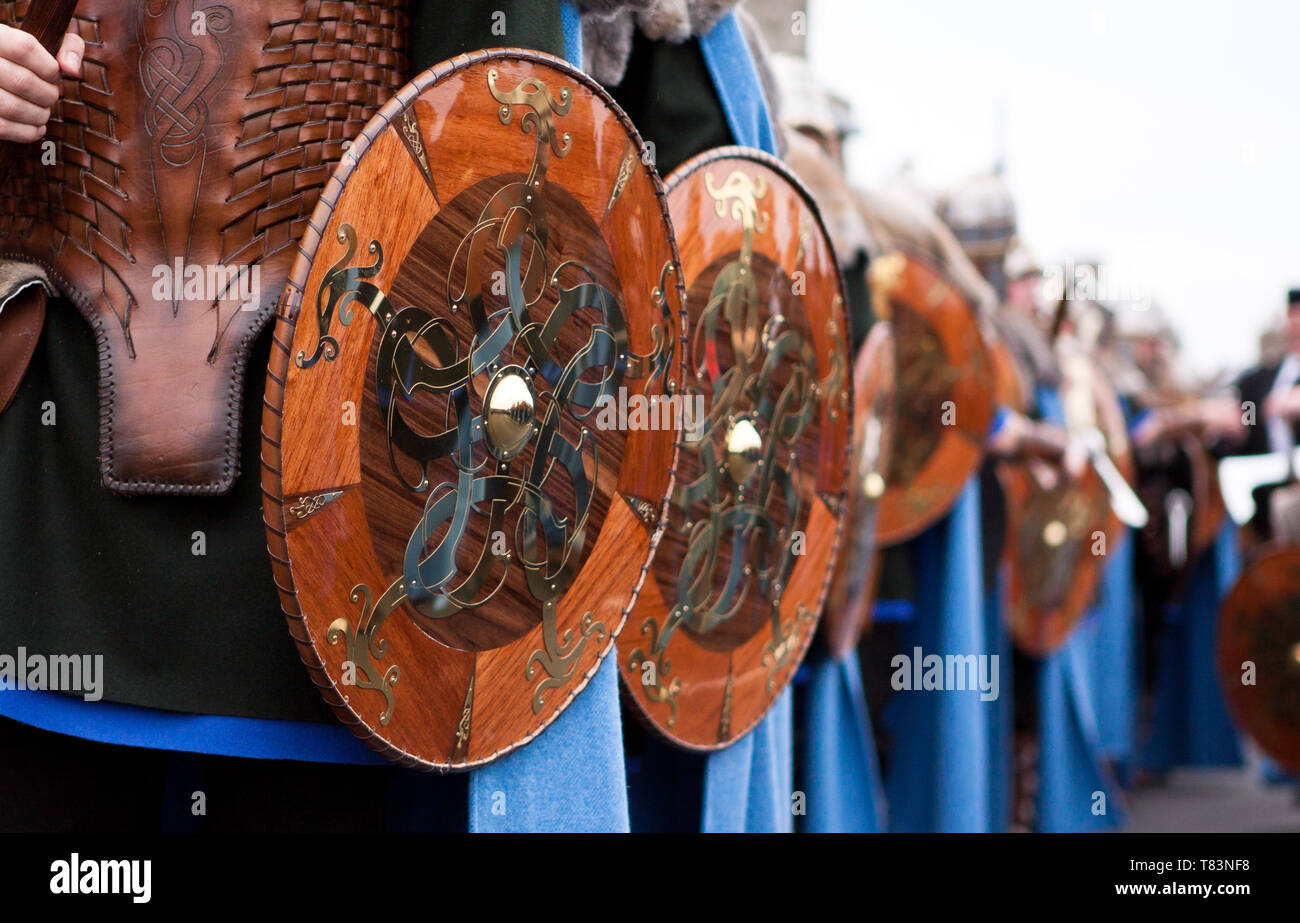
[1141,523,1242,771]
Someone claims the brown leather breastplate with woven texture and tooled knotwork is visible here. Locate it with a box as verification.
[0,0,407,494]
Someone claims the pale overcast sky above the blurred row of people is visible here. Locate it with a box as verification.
[809,0,1300,372]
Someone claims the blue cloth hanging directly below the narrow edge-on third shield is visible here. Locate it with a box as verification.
[801,651,885,833]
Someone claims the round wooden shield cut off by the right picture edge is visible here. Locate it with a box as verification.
[1216,547,1300,772]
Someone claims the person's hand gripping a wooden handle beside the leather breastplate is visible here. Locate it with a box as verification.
[0,25,86,143]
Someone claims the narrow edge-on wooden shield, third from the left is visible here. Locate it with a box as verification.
[822,321,894,658]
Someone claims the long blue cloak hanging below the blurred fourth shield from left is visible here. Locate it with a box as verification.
[883,477,1005,832]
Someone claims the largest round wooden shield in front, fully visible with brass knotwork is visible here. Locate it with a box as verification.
[263,51,684,768]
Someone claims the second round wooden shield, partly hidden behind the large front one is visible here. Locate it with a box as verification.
[619,148,853,750]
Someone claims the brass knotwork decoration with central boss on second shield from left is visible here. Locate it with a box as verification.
[627,169,821,727]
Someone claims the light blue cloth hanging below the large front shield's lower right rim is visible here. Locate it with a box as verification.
[469,654,628,833]
